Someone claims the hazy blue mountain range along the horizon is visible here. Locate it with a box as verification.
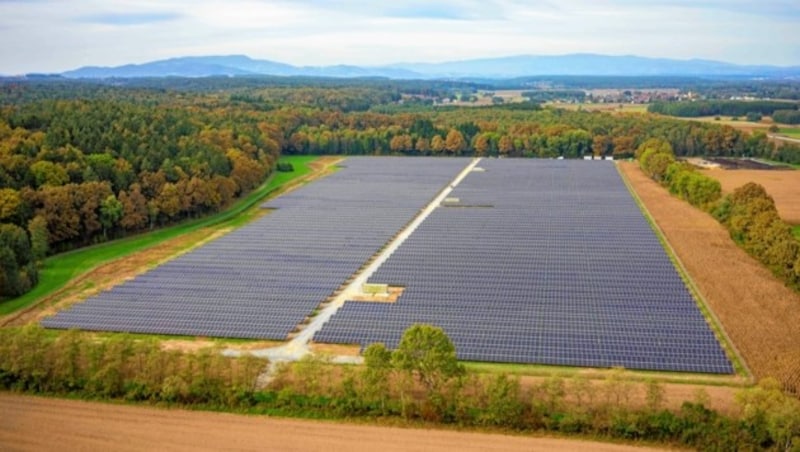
[61,54,800,79]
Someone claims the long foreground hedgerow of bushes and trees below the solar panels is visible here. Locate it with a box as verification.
[0,325,800,450]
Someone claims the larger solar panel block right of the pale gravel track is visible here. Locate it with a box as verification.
[315,160,732,373]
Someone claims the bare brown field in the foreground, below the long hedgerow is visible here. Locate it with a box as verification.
[0,393,656,452]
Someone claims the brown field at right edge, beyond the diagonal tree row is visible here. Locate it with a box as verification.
[706,169,800,224]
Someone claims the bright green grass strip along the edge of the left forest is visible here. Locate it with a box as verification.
[0,156,317,315]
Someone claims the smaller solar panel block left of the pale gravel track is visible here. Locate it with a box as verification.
[42,158,468,339]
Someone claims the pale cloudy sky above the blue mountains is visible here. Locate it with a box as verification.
[0,0,800,74]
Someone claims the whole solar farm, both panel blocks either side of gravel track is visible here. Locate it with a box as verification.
[42,157,733,374]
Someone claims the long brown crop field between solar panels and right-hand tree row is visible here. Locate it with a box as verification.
[619,163,800,391]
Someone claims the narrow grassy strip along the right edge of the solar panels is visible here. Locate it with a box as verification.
[614,163,753,380]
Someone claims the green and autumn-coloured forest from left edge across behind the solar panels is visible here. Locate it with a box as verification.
[0,78,800,297]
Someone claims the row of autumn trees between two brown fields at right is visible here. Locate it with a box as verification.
[637,140,800,291]
